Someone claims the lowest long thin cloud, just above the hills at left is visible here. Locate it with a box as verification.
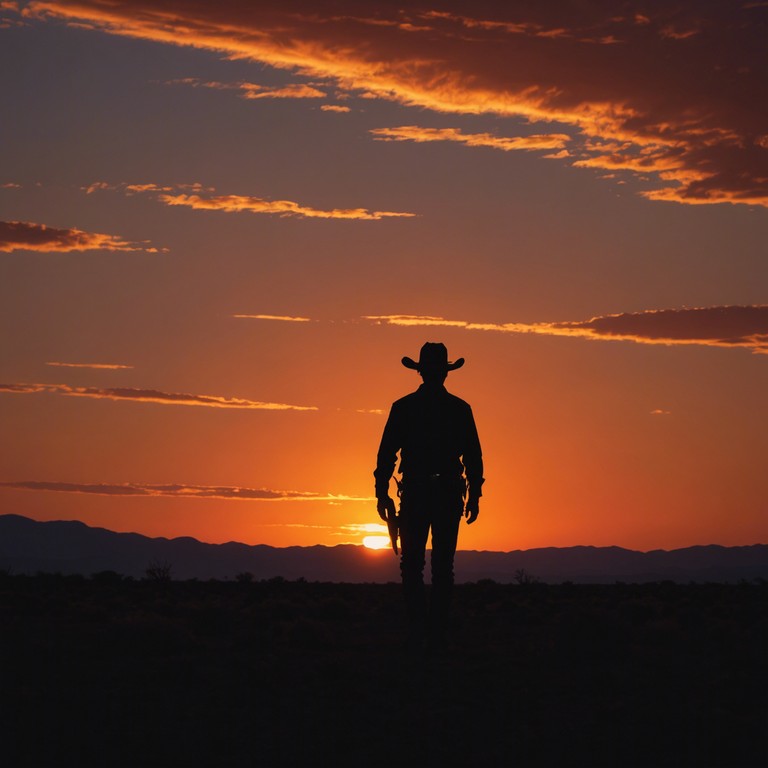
[0,480,373,503]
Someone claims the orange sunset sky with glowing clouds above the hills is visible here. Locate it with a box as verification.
[0,0,768,550]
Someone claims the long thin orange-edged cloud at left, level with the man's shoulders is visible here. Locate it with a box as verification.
[0,384,317,411]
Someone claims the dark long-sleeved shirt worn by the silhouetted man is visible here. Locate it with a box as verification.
[373,384,483,498]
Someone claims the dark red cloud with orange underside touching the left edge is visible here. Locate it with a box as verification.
[0,221,158,253]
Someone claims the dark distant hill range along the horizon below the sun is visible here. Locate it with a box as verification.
[0,515,768,584]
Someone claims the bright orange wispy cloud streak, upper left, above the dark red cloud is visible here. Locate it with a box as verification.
[82,181,416,221]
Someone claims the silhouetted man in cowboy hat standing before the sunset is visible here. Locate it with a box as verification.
[374,342,483,645]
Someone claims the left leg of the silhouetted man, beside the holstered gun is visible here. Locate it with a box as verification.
[400,488,430,645]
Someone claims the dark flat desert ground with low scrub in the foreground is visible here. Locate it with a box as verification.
[0,567,768,768]
